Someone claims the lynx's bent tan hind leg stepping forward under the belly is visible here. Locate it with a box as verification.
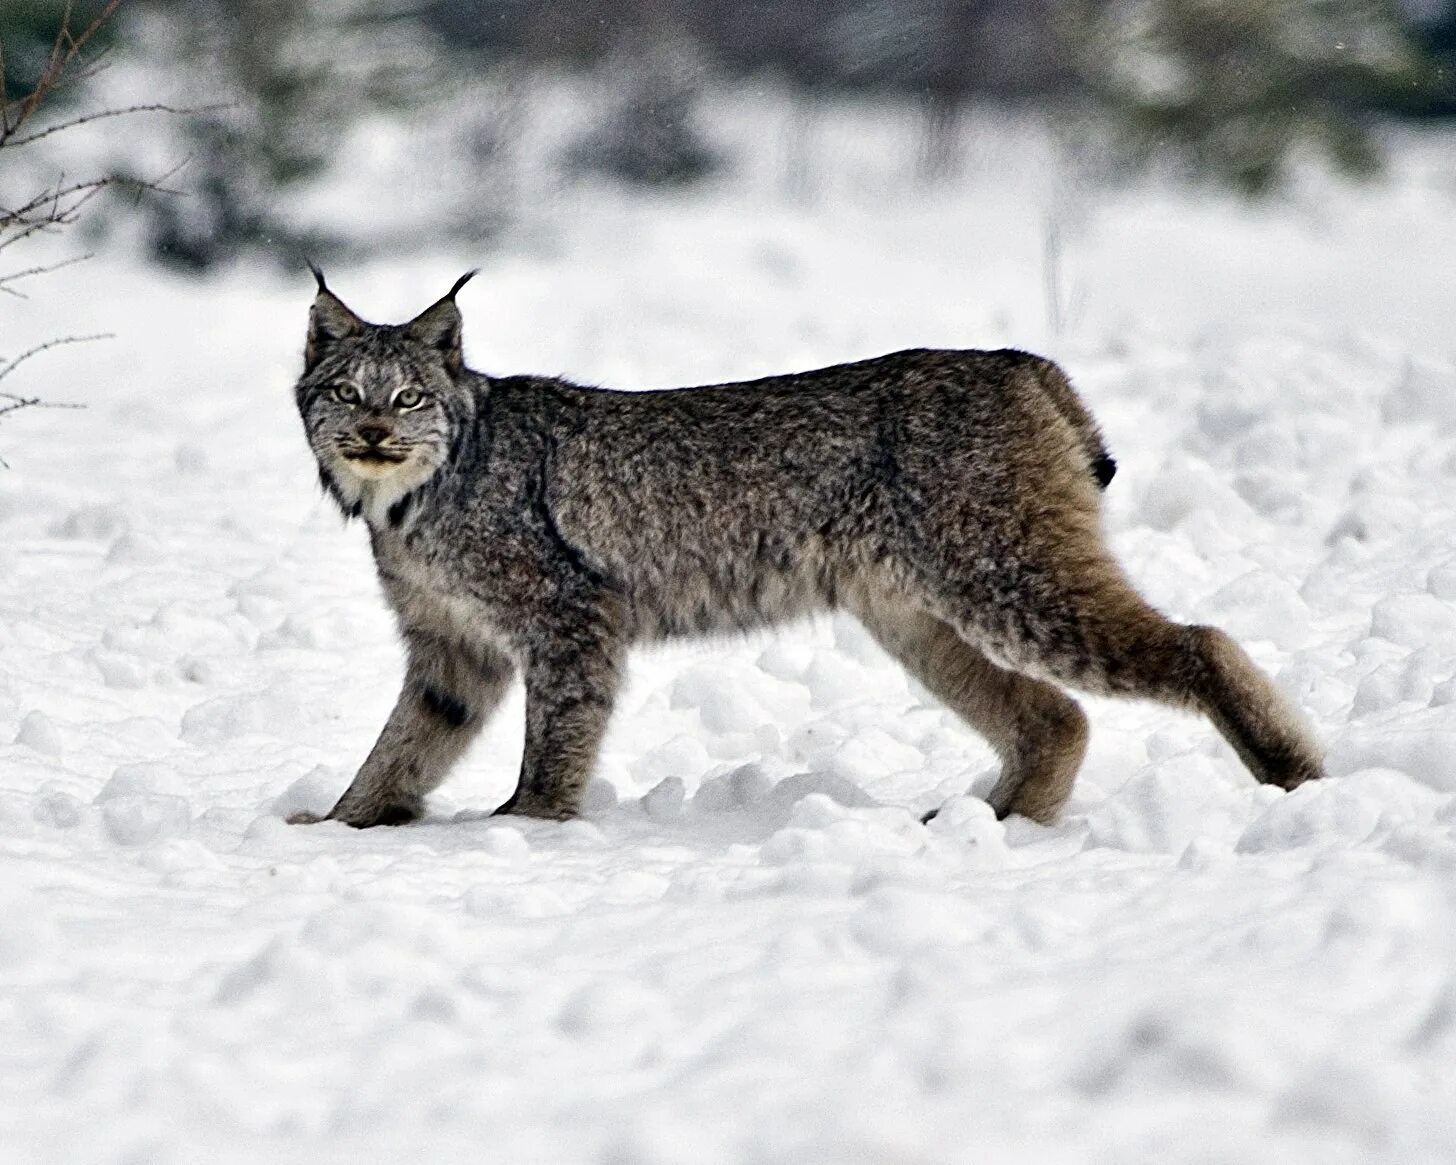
[860,604,1088,823]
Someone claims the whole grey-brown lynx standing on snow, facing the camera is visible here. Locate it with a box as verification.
[283,271,1321,827]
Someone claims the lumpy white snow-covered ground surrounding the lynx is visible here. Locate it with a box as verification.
[0,111,1456,1165]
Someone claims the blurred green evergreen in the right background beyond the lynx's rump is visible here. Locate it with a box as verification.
[1066,0,1433,194]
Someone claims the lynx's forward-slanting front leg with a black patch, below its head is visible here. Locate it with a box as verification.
[288,635,511,829]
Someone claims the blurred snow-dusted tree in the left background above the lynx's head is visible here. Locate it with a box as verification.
[132,0,435,269]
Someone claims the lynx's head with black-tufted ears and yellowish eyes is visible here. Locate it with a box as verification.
[296,264,476,524]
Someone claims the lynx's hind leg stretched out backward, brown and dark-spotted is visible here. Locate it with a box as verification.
[926,545,1324,789]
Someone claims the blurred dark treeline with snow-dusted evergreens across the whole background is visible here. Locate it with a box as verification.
[0,0,1456,269]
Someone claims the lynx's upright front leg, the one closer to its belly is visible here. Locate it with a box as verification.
[496,632,625,821]
